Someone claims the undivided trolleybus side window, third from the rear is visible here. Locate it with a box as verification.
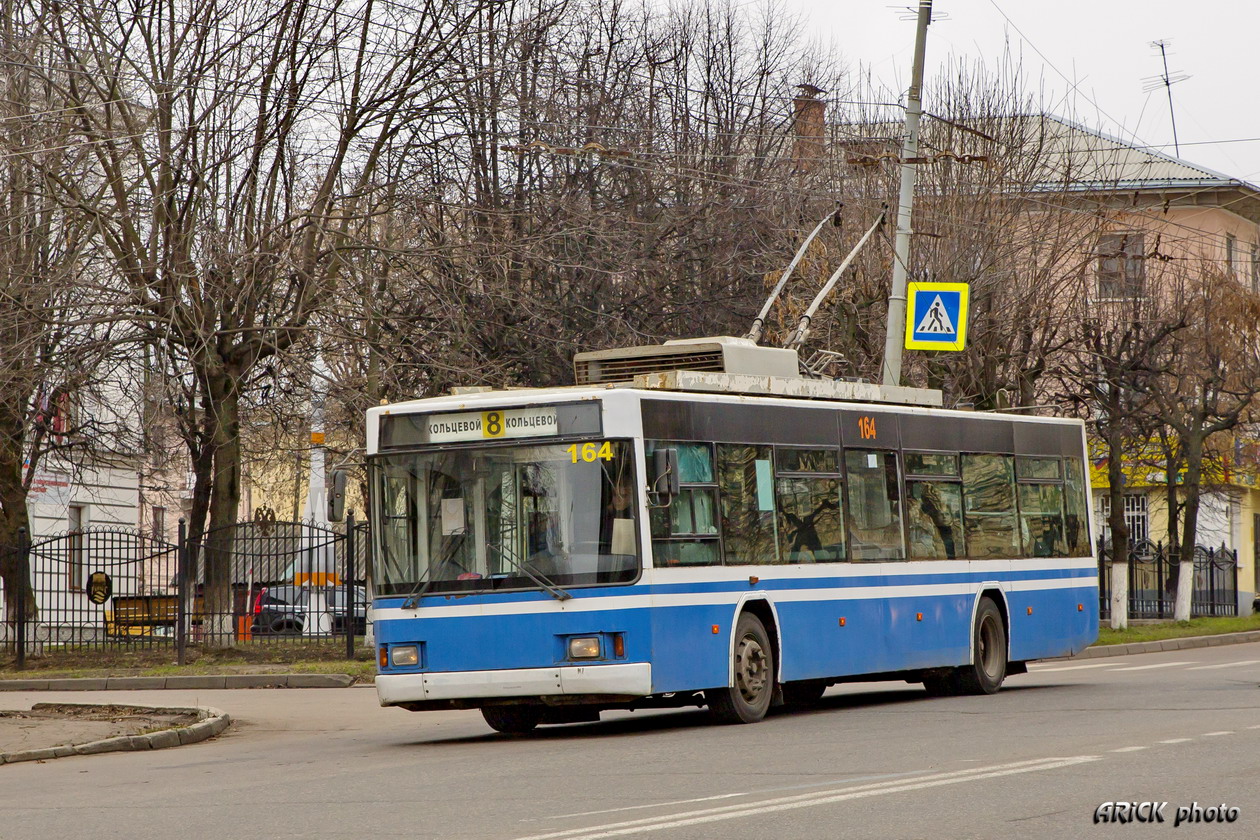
[963,455,1019,559]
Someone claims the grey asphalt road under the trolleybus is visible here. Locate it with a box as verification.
[0,644,1260,840]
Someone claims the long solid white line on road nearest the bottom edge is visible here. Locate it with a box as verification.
[519,756,1100,840]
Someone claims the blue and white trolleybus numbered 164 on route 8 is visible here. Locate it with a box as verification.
[368,339,1099,732]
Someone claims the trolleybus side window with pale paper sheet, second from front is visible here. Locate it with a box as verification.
[717,443,779,565]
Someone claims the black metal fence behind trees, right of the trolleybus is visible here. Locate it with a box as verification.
[1099,540,1239,618]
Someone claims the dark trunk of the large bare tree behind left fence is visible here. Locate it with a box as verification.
[203,365,241,647]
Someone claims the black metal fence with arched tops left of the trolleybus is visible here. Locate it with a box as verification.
[0,519,369,667]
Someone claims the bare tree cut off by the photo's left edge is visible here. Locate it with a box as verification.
[0,0,135,627]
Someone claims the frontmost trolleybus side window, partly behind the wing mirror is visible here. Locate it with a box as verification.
[645,441,722,567]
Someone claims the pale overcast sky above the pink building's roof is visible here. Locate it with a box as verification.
[781,0,1260,184]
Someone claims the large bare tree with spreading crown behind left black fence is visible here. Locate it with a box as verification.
[34,0,496,645]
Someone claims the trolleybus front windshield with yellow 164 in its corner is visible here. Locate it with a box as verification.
[372,441,639,596]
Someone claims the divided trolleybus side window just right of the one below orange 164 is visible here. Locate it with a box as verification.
[906,452,966,560]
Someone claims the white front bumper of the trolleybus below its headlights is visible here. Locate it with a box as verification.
[377,662,651,705]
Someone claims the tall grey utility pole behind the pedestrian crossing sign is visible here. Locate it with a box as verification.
[881,0,932,385]
